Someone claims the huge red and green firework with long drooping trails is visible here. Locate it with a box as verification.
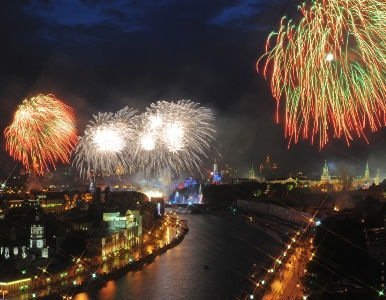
[257,0,386,148]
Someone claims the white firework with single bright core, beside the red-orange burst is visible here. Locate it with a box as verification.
[74,107,135,178]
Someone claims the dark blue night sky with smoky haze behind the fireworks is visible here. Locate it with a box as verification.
[0,0,386,177]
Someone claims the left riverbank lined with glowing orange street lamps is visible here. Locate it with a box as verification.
[7,220,189,300]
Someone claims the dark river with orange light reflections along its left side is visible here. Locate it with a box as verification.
[75,215,282,300]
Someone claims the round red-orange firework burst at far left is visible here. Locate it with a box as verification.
[5,94,77,174]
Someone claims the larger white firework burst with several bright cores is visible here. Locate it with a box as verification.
[134,100,215,174]
